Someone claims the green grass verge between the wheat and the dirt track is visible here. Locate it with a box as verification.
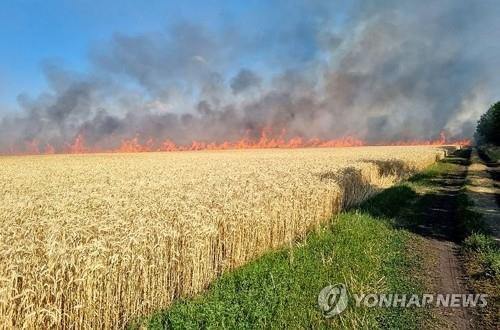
[135,150,490,329]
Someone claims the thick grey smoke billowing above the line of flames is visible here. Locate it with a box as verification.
[0,0,500,152]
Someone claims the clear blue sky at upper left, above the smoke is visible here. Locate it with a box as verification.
[0,0,346,112]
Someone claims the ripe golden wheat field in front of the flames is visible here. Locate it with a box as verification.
[0,146,445,329]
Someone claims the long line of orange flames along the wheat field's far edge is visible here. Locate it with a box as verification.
[0,129,471,155]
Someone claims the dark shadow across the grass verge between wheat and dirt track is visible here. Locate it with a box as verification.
[359,149,477,242]
